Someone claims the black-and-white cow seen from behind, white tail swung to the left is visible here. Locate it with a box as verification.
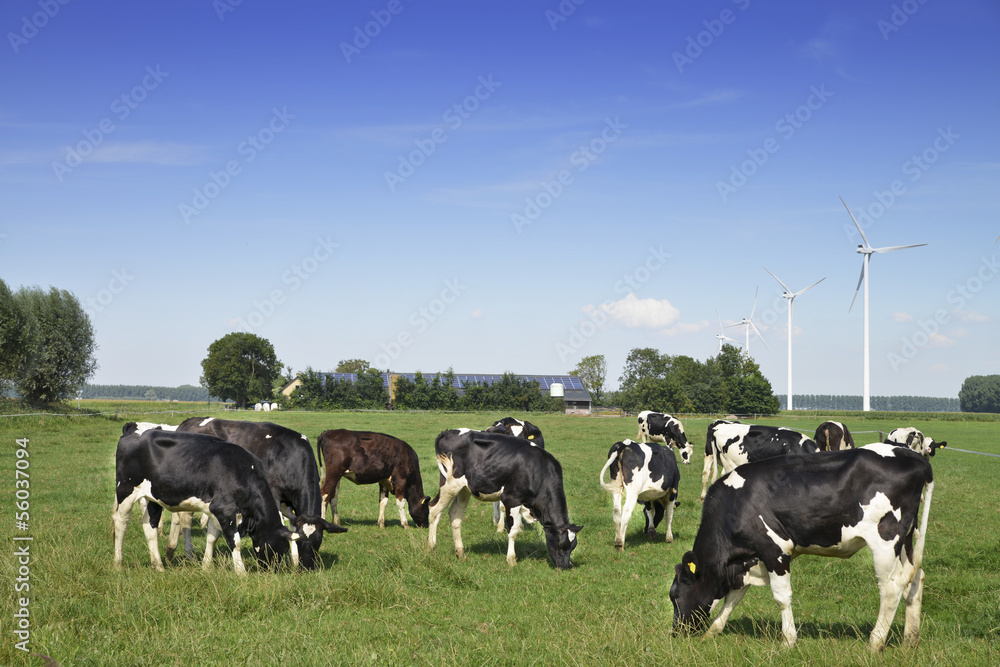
[598,440,681,551]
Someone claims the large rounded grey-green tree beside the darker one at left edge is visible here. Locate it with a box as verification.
[14,287,97,403]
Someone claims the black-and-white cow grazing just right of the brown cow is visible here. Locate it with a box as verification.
[428,428,581,569]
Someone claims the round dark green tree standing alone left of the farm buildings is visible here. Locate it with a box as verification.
[201,331,283,408]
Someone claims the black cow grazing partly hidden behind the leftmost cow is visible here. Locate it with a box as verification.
[177,417,340,570]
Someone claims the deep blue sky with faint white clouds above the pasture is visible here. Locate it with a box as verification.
[0,0,1000,396]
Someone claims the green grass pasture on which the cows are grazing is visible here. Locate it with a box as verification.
[0,401,1000,665]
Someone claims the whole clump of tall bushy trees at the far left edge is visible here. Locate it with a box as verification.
[0,280,97,403]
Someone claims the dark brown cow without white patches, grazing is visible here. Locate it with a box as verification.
[316,429,430,528]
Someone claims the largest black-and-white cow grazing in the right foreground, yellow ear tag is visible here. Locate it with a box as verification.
[670,444,934,650]
